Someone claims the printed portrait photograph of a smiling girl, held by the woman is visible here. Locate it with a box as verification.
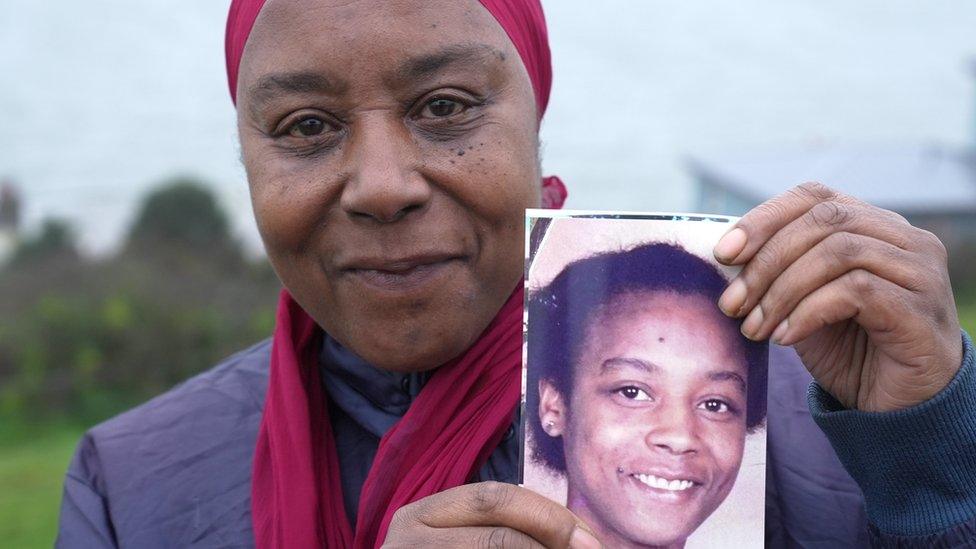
[522,210,768,547]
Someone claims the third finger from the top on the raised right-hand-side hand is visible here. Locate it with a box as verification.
[742,232,938,343]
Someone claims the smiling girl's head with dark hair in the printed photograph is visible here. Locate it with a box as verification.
[526,243,767,547]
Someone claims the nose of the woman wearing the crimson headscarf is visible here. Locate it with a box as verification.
[340,115,431,223]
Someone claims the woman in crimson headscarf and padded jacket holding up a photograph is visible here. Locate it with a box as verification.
[59,0,976,547]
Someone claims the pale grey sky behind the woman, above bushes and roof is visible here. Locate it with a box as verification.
[0,0,976,252]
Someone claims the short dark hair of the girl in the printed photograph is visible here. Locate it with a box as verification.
[525,243,768,472]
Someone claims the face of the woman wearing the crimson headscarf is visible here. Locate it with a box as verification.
[237,0,540,371]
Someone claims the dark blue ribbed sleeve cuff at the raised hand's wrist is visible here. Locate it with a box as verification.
[808,333,976,547]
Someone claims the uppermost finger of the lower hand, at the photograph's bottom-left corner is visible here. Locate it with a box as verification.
[387,482,600,549]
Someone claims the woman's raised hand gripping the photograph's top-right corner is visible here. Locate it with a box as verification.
[715,183,962,412]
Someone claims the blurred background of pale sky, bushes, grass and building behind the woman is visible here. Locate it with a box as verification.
[0,0,976,547]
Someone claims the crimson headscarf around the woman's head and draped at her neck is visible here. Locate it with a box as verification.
[225,0,566,548]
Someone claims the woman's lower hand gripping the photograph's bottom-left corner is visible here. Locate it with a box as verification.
[383,482,600,549]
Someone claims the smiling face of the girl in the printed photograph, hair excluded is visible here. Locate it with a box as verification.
[542,293,748,547]
